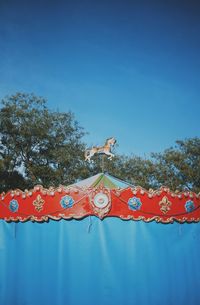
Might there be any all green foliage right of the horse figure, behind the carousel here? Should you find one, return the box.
[86,138,200,192]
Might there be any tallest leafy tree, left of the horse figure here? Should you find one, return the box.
[0,93,86,190]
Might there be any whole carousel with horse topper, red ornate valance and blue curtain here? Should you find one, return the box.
[0,138,200,305]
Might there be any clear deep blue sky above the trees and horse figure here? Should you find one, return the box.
[0,0,200,156]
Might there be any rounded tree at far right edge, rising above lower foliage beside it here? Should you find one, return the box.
[152,137,200,192]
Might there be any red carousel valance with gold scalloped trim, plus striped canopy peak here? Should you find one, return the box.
[0,174,200,223]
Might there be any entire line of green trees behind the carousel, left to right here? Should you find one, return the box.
[0,93,200,192]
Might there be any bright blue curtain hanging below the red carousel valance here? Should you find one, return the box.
[0,217,200,305]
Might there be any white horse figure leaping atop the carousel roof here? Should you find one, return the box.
[85,138,117,162]
